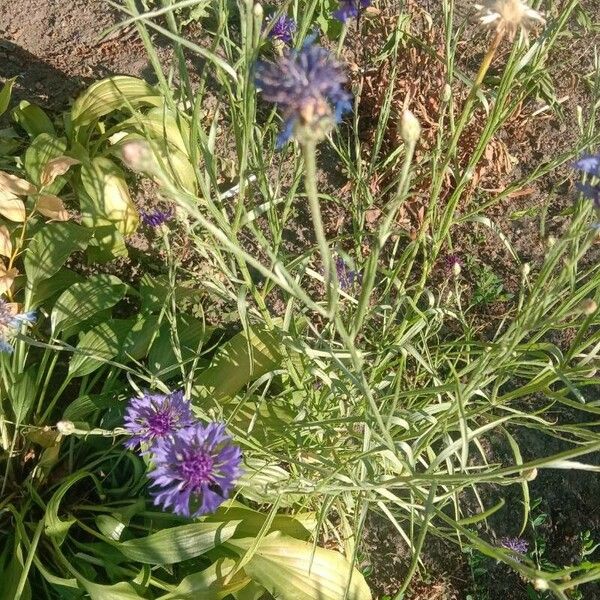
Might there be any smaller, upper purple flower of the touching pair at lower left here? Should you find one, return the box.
[124,391,194,450]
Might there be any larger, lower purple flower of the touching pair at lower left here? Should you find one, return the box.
[148,423,242,517]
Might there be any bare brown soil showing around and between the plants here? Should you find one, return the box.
[0,0,600,600]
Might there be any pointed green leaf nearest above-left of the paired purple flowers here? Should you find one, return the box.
[69,320,131,377]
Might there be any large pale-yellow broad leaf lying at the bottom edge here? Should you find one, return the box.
[226,532,371,600]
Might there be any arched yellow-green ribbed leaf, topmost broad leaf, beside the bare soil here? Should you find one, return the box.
[71,75,163,127]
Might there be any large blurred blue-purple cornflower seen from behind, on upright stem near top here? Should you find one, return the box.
[256,40,352,147]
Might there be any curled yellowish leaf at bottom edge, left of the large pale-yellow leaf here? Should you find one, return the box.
[159,558,251,600]
